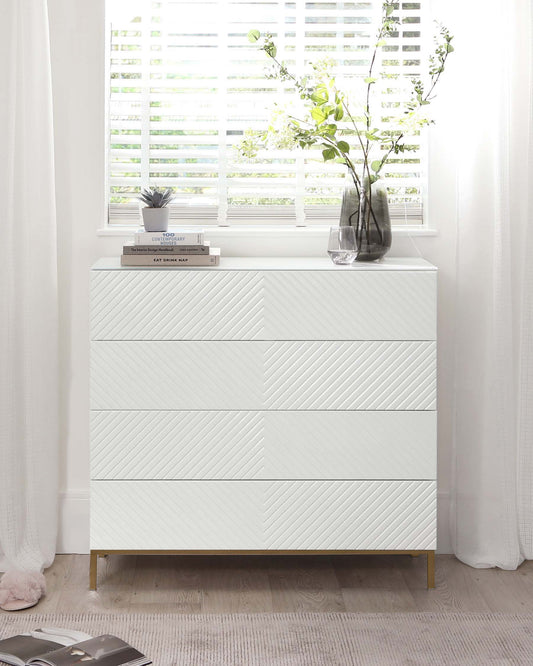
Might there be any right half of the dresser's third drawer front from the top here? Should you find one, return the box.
[263,411,437,479]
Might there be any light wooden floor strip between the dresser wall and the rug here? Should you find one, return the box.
[24,555,533,613]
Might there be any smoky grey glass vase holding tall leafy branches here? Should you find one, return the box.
[339,174,392,261]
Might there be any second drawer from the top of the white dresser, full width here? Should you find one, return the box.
[91,341,436,410]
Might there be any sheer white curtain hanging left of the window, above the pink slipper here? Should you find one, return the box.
[0,0,58,571]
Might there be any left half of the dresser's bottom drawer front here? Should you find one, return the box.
[91,481,263,550]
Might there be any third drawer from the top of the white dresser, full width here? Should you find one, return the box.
[91,411,436,479]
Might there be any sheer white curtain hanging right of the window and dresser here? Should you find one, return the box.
[452,0,533,569]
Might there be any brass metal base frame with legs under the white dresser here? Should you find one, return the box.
[89,550,435,590]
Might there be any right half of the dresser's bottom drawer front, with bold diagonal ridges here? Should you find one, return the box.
[264,481,436,550]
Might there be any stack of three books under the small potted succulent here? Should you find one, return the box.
[121,227,220,266]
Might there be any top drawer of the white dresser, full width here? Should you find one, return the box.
[91,270,437,340]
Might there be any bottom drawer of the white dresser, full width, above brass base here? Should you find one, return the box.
[91,481,436,550]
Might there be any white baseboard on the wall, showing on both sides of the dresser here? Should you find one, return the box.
[57,490,452,554]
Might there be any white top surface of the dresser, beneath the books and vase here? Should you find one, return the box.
[92,257,437,272]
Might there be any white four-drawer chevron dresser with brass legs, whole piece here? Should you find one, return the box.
[90,257,437,589]
